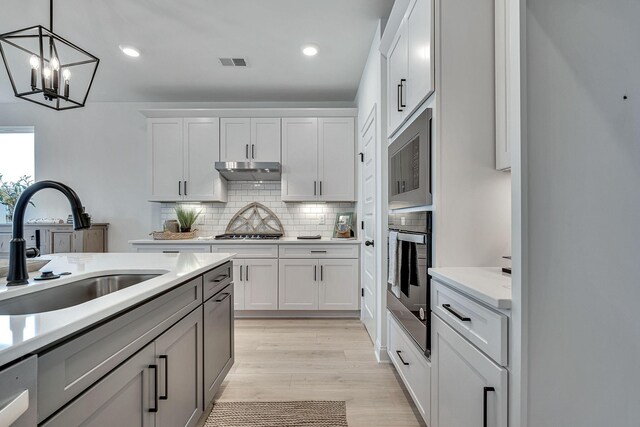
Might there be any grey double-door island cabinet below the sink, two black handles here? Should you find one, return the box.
[44,309,204,427]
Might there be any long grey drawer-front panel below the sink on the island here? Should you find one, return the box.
[38,277,202,422]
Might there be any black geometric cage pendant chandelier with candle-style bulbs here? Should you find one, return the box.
[0,0,100,111]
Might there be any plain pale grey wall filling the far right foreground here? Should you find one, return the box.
[523,0,640,427]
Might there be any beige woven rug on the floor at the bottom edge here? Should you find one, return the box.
[205,401,348,427]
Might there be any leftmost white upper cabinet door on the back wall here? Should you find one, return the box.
[147,119,184,202]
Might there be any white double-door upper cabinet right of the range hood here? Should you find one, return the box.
[282,117,356,202]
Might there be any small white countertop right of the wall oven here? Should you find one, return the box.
[429,267,511,309]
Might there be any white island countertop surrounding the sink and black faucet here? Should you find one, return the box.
[0,253,234,366]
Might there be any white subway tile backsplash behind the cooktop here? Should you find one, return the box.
[160,181,356,237]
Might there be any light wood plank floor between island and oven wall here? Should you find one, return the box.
[216,319,424,427]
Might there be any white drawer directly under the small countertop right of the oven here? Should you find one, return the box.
[431,280,508,366]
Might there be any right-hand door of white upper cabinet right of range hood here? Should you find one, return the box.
[318,117,356,202]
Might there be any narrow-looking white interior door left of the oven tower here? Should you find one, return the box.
[360,107,380,341]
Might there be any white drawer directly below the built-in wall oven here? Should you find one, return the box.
[387,311,431,424]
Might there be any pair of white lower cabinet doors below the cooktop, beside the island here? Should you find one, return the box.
[233,259,278,310]
